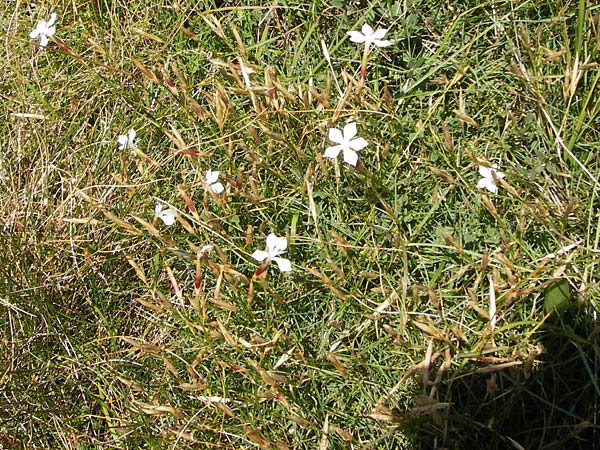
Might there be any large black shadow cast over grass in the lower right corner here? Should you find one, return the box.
[409,312,600,450]
